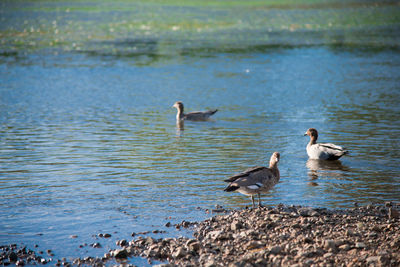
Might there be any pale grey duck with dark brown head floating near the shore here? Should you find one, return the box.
[304,128,349,160]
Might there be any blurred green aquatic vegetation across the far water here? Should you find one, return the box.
[0,0,400,55]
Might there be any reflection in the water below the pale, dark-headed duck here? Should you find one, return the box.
[306,159,349,186]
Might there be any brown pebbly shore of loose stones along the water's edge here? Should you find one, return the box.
[0,203,400,267]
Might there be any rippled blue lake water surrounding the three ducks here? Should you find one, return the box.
[0,0,400,265]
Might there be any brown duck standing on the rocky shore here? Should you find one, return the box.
[224,152,280,209]
